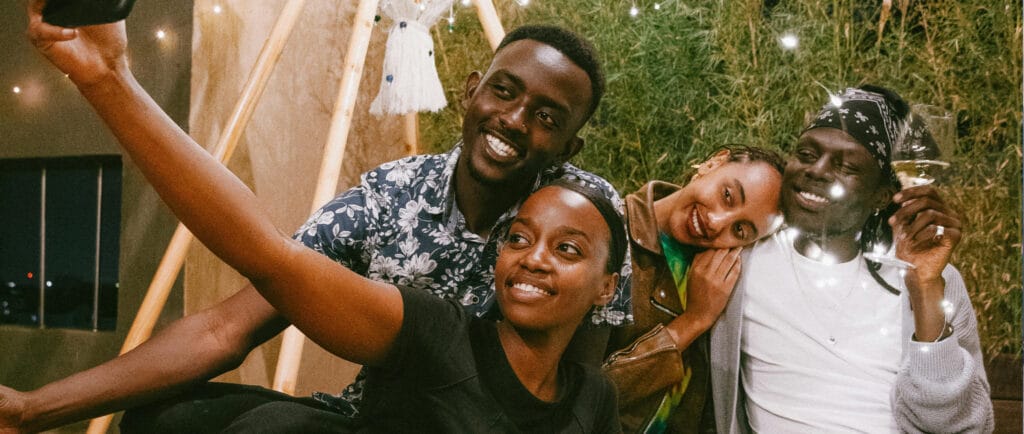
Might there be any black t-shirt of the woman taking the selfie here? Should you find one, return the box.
[352,287,620,433]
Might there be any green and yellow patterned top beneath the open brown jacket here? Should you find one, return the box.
[643,233,697,434]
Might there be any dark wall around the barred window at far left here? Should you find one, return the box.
[0,0,193,431]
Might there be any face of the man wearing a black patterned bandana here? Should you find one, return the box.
[782,128,892,235]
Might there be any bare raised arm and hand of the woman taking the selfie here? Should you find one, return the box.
[29,1,402,364]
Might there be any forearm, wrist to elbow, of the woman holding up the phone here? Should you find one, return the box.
[80,64,287,277]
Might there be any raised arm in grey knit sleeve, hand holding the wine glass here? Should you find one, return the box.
[889,185,993,432]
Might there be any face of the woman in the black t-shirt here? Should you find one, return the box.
[495,186,617,331]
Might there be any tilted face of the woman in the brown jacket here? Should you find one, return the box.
[658,162,782,249]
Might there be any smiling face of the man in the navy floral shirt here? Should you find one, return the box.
[460,39,591,185]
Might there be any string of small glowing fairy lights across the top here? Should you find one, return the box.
[9,0,800,102]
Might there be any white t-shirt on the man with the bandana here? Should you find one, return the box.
[737,232,902,433]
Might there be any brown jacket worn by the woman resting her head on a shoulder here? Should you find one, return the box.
[603,181,715,433]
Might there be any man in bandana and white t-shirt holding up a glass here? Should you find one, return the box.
[711,86,993,433]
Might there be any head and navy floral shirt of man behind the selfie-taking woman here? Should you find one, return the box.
[295,27,632,414]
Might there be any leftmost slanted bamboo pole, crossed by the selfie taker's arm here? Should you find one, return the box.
[86,0,305,434]
